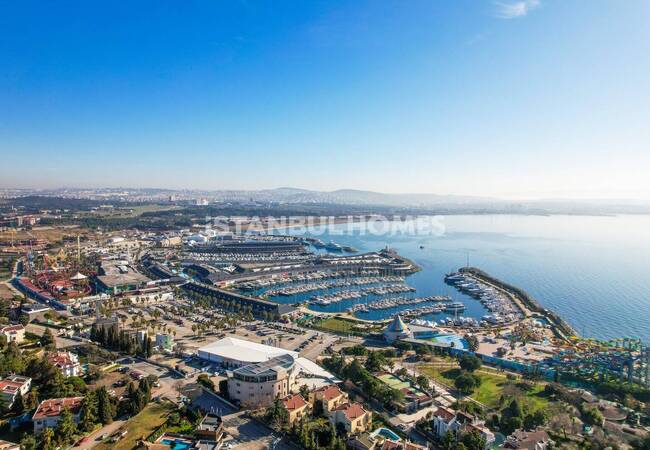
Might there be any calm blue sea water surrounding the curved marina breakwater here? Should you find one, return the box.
[280,215,650,342]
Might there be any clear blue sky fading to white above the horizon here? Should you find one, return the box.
[0,0,650,199]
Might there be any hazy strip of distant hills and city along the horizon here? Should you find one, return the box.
[0,187,650,214]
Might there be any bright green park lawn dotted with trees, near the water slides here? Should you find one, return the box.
[418,366,548,411]
